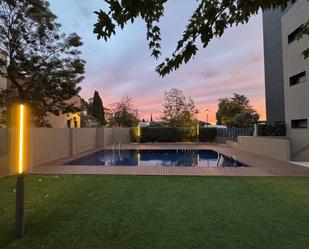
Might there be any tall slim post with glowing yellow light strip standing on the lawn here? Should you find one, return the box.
[15,104,25,239]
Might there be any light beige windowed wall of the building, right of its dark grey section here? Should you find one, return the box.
[281,0,309,161]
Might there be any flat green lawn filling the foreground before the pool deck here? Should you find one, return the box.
[0,176,309,249]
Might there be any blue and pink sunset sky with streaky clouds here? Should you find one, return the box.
[50,0,265,122]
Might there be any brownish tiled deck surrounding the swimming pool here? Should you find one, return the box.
[33,143,309,176]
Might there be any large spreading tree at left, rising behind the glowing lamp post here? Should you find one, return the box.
[0,0,85,126]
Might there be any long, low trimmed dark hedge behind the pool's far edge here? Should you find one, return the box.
[131,127,217,143]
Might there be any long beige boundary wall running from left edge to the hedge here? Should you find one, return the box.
[0,128,130,177]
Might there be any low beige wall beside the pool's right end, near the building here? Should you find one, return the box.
[226,136,291,161]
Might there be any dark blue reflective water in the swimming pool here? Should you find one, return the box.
[66,150,248,167]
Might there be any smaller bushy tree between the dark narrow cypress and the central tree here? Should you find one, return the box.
[109,95,138,127]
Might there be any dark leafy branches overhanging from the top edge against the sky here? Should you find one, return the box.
[94,0,304,76]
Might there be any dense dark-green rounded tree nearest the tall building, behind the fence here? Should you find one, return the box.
[216,93,259,127]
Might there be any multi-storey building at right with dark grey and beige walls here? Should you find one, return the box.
[264,0,309,161]
